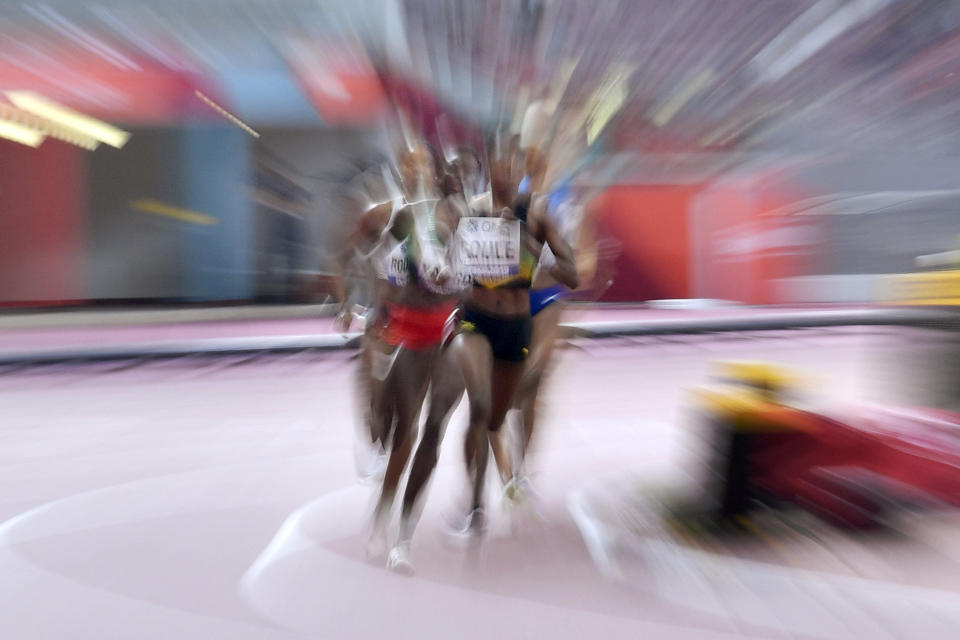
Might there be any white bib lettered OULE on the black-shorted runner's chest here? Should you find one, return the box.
[457,218,520,277]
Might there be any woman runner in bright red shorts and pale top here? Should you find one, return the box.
[368,140,459,556]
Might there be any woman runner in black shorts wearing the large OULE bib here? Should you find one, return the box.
[452,132,579,535]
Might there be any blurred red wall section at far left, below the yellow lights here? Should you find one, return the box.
[0,139,87,305]
